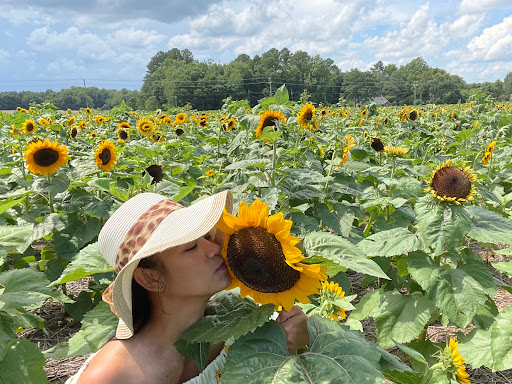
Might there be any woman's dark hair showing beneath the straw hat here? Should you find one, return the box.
[132,255,161,334]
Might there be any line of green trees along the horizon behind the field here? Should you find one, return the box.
[0,48,512,110]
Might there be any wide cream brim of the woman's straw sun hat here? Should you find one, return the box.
[112,191,233,339]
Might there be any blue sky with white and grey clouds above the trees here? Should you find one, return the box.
[0,0,512,92]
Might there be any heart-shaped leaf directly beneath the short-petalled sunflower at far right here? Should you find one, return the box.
[414,196,471,256]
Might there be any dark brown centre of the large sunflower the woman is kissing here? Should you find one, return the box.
[227,227,300,293]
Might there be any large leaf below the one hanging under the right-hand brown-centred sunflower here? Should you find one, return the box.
[407,251,488,328]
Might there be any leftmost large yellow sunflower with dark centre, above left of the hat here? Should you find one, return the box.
[23,140,69,176]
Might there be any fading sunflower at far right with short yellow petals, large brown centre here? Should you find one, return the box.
[427,159,476,204]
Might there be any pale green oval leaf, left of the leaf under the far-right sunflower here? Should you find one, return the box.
[357,228,421,256]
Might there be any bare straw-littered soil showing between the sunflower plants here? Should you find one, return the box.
[20,246,512,384]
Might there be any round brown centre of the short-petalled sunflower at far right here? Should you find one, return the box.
[432,167,471,199]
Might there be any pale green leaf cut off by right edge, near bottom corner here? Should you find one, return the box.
[458,306,512,371]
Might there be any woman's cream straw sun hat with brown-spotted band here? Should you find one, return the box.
[98,191,233,339]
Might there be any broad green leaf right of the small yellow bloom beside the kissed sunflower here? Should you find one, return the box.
[374,291,435,348]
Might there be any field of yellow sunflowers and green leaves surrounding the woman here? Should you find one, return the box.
[0,85,512,384]
